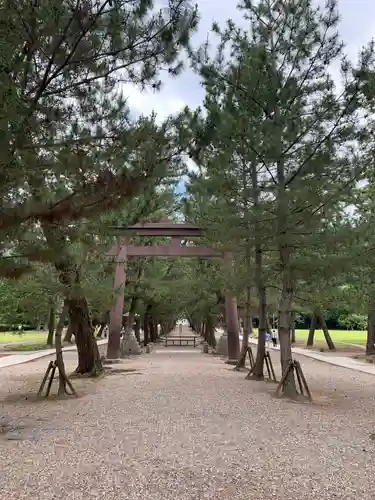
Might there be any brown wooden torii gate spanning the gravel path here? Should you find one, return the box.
[107,222,240,363]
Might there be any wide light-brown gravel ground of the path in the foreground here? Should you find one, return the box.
[0,344,375,500]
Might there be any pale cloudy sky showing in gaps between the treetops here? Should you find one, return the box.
[124,0,375,191]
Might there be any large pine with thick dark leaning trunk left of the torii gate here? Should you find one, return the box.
[0,0,197,373]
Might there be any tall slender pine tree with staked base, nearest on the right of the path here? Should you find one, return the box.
[189,0,372,396]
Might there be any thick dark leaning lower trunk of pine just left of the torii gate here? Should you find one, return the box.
[67,297,102,376]
